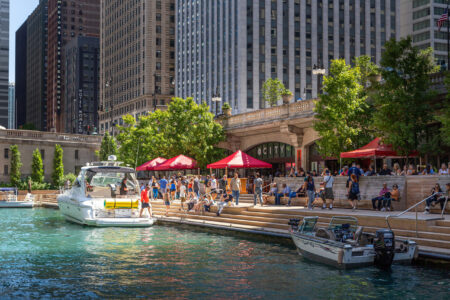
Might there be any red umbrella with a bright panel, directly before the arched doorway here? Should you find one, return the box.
[207,150,272,169]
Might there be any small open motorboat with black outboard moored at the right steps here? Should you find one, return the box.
[289,216,418,269]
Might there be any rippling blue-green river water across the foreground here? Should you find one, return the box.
[0,209,450,299]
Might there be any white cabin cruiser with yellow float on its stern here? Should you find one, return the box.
[58,156,155,227]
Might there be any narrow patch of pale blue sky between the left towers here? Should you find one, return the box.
[9,0,39,82]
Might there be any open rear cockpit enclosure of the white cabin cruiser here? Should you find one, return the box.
[84,170,139,198]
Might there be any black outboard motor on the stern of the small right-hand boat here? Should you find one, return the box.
[373,229,395,269]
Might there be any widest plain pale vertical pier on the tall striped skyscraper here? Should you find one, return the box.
[235,1,247,112]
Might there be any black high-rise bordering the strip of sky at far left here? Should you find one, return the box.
[25,0,48,131]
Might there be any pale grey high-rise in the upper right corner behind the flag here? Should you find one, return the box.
[400,0,450,66]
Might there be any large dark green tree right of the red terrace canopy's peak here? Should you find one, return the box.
[373,37,436,156]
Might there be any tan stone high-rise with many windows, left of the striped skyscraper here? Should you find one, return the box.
[99,0,175,133]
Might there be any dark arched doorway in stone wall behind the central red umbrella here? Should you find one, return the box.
[245,142,295,175]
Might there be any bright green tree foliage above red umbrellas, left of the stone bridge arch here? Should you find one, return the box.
[117,98,225,167]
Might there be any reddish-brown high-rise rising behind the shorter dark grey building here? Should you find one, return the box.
[47,0,99,132]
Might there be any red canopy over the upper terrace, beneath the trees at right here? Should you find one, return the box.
[341,138,418,158]
